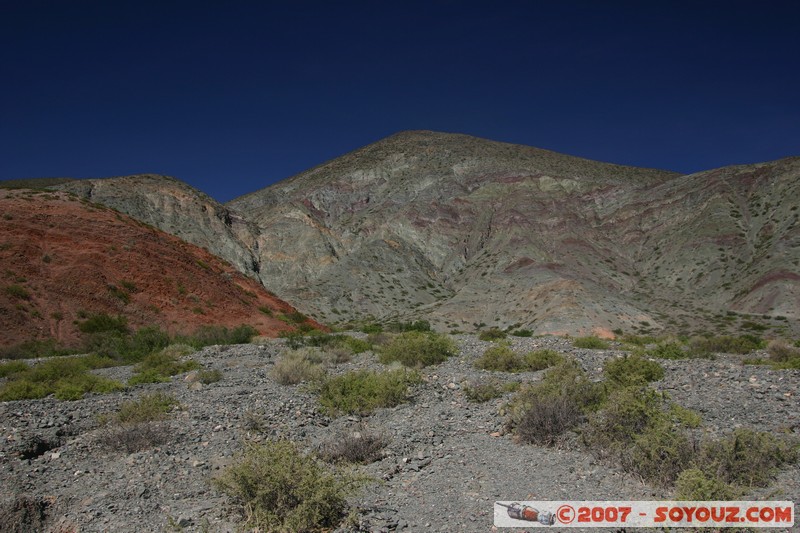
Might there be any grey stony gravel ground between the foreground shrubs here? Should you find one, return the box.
[0,335,800,532]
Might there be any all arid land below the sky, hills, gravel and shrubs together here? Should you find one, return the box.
[0,131,800,533]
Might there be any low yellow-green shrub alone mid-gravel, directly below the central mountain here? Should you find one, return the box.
[319,369,421,415]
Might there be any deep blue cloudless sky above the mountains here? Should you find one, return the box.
[0,0,800,201]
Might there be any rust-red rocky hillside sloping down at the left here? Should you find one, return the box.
[0,190,319,347]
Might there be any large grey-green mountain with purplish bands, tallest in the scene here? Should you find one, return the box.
[228,132,800,333]
